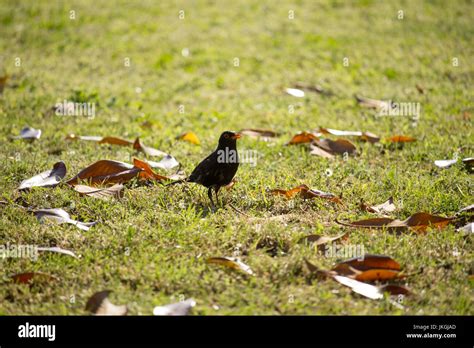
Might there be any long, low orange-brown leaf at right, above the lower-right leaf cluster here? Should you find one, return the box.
[336,213,454,232]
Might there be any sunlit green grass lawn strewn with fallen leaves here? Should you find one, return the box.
[0,0,474,315]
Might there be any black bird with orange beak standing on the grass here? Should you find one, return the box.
[171,131,241,205]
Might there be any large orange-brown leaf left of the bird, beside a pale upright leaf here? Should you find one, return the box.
[66,160,143,186]
